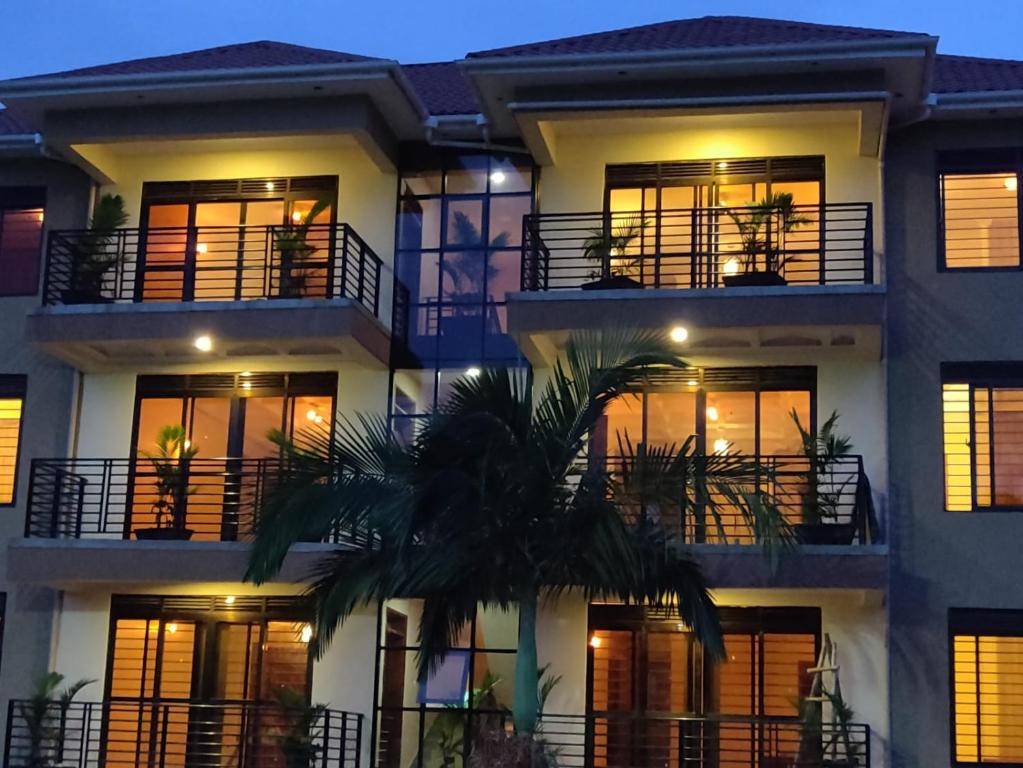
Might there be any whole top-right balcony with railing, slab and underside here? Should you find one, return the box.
[508,202,883,364]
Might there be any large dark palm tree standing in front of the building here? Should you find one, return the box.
[247,330,769,752]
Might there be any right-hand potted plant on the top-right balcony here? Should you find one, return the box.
[721,192,810,287]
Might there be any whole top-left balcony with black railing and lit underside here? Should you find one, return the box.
[28,224,390,371]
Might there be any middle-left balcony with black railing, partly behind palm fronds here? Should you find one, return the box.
[10,457,365,583]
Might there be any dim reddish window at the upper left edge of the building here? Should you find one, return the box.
[0,187,46,296]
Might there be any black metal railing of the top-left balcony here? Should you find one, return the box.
[43,224,383,315]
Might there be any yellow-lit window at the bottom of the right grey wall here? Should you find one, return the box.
[948,609,1023,765]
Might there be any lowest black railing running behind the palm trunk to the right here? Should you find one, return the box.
[376,707,871,768]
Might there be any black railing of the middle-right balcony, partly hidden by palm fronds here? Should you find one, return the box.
[594,454,878,545]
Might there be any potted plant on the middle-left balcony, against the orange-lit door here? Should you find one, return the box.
[135,424,198,540]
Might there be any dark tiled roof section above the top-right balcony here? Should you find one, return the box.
[469,16,928,58]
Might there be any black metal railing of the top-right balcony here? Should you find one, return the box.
[522,202,875,290]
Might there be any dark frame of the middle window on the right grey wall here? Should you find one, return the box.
[939,362,1023,514]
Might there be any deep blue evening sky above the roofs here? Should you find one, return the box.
[0,0,1023,79]
